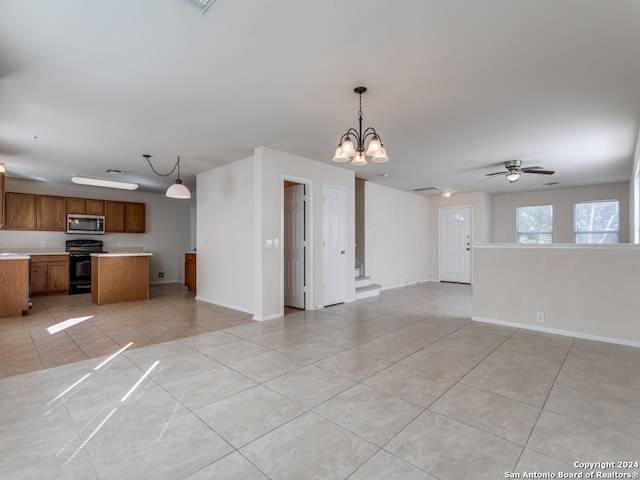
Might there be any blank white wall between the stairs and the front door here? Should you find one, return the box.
[363,182,430,289]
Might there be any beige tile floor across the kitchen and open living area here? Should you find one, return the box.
[0,283,640,480]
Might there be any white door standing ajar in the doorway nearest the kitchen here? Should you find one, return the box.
[284,185,305,308]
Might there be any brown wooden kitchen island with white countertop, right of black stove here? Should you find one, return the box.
[91,252,153,305]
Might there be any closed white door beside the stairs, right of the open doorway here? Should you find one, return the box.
[322,186,347,306]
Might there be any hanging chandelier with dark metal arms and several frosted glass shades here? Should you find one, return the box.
[333,87,389,165]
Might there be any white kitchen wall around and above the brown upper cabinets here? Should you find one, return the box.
[0,177,191,283]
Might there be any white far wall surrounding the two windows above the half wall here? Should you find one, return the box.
[493,182,630,243]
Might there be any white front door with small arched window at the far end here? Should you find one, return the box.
[438,207,471,283]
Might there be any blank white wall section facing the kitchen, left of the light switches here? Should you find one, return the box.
[196,157,257,313]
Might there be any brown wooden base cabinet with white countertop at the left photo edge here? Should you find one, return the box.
[0,253,29,318]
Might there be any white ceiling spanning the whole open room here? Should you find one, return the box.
[0,0,640,193]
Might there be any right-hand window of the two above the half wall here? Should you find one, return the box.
[573,200,620,243]
